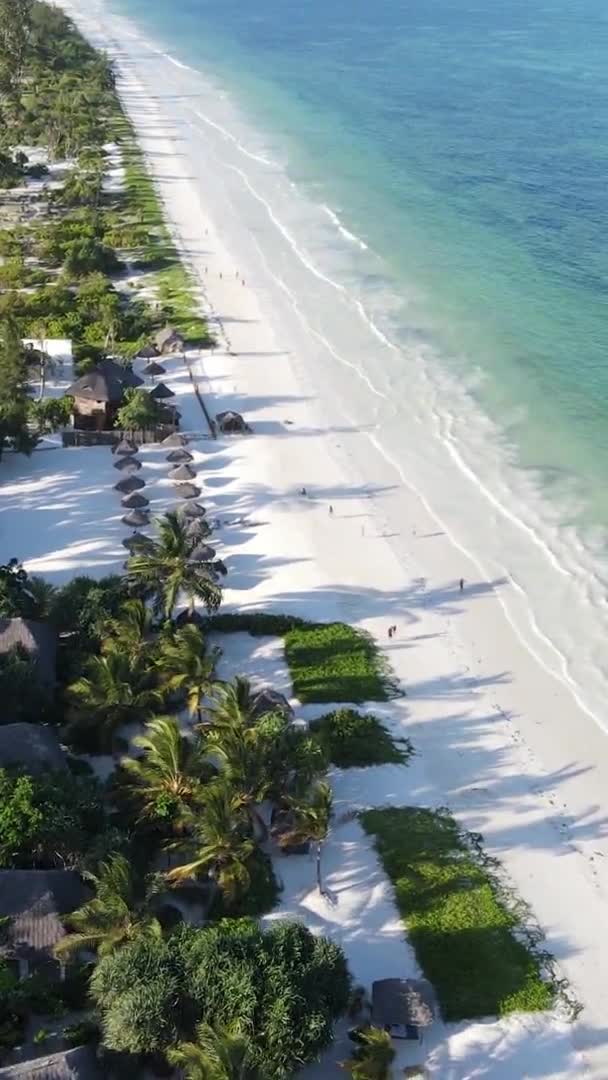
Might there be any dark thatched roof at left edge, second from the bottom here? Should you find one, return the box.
[0,870,87,956]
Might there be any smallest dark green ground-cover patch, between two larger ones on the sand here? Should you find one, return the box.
[310,708,413,769]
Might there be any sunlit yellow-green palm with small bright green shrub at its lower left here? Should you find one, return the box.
[122,716,204,835]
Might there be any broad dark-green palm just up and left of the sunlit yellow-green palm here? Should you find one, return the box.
[67,647,163,750]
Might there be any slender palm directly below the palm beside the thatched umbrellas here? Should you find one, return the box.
[158,623,220,723]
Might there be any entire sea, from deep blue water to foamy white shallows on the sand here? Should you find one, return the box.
[112,0,608,723]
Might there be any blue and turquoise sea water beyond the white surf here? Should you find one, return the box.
[111,0,608,525]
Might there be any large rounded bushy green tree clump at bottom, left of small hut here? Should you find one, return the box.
[92,919,350,1080]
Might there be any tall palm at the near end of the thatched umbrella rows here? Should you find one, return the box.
[127,513,221,619]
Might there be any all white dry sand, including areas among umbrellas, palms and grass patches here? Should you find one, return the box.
[0,0,608,1080]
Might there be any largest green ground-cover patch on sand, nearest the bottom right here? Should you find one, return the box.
[361,808,556,1021]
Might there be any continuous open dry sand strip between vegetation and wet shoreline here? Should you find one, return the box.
[29,0,608,1080]
